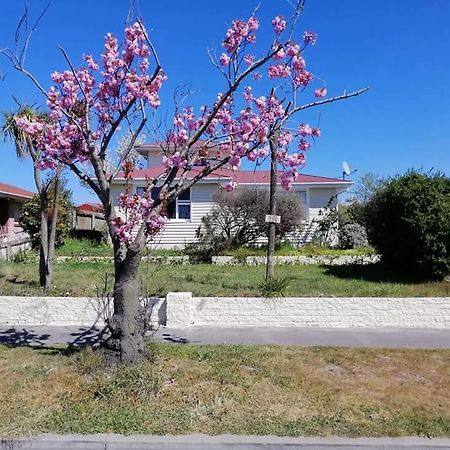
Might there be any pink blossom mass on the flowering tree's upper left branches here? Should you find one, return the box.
[18,23,166,174]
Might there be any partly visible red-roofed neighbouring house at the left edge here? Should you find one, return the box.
[0,183,34,259]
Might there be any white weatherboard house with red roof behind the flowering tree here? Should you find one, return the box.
[112,144,352,248]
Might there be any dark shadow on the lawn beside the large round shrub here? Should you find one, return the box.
[324,263,433,284]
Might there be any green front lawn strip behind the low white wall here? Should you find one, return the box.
[0,260,450,297]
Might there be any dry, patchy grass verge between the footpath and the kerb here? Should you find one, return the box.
[0,344,450,436]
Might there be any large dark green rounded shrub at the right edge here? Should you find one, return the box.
[367,171,450,278]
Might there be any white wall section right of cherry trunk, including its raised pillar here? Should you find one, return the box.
[167,293,450,328]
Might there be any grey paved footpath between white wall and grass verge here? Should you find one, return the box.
[0,325,450,348]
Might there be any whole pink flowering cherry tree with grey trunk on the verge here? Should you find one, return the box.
[6,0,365,362]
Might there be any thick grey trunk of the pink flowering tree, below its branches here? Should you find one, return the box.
[105,244,146,363]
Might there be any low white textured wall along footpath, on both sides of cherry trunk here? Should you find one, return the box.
[0,292,450,329]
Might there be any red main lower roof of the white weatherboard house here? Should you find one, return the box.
[116,166,351,184]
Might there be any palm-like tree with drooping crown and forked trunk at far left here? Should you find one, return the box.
[1,105,62,288]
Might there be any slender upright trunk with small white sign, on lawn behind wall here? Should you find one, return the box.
[266,134,278,280]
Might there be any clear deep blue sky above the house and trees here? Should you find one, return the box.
[0,0,450,202]
